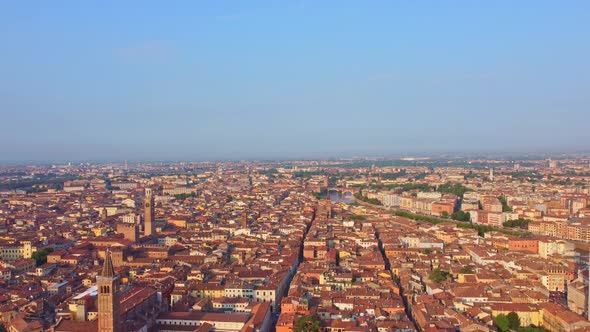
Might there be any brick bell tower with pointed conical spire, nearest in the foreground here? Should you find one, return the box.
[96,249,121,332]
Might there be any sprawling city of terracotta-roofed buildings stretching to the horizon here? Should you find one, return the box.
[0,156,590,332]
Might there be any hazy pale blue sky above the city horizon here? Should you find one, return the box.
[0,0,590,162]
